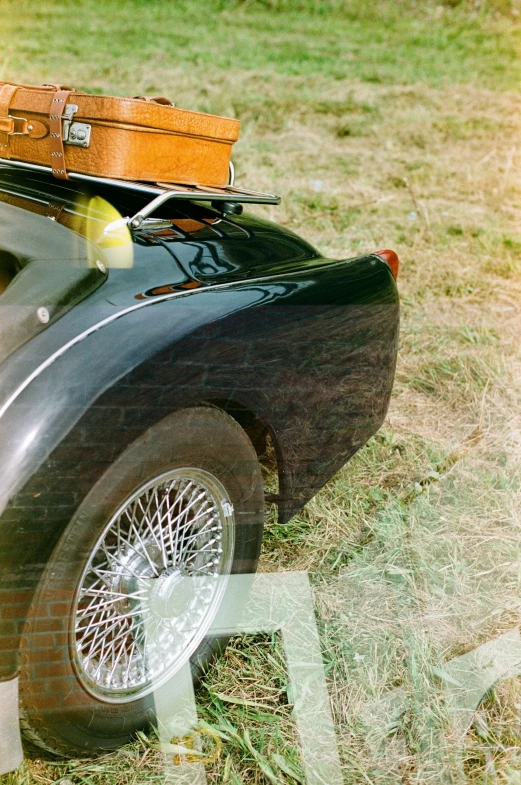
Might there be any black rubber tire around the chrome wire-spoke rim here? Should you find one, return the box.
[20,407,264,757]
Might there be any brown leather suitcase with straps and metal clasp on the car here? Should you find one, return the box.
[0,82,240,186]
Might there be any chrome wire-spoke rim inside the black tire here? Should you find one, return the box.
[73,468,234,703]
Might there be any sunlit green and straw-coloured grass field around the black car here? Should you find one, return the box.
[0,0,521,785]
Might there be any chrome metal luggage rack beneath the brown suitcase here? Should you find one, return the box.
[0,158,280,229]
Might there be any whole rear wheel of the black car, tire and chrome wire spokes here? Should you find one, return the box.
[20,407,263,755]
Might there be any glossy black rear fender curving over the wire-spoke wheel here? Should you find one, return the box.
[0,257,398,676]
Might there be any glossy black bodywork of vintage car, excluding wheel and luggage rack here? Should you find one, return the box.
[0,165,399,751]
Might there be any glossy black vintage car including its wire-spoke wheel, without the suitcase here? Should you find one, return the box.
[0,163,399,756]
